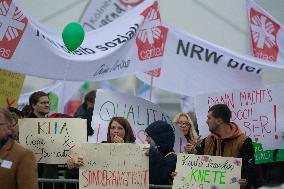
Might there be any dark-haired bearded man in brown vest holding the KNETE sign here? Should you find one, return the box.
[191,104,254,189]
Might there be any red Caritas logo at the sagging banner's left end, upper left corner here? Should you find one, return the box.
[0,0,28,59]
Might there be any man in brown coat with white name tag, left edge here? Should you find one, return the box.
[0,108,38,189]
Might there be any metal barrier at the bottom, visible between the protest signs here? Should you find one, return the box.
[38,178,172,189]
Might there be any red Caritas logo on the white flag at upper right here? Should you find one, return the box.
[250,8,280,61]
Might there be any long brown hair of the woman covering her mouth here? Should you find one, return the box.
[107,117,136,143]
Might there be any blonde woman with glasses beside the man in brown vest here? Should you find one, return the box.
[173,112,201,153]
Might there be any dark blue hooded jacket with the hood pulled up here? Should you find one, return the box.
[145,121,177,185]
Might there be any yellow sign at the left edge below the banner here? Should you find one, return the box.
[0,69,25,108]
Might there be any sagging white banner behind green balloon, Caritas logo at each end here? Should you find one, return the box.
[0,0,164,81]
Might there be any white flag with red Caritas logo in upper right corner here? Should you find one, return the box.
[246,0,284,64]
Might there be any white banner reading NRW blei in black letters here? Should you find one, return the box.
[137,23,284,96]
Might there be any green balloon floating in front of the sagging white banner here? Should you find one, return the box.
[62,22,85,52]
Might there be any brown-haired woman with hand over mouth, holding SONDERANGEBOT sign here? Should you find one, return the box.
[67,117,135,169]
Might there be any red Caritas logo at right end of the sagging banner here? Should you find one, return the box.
[136,2,168,61]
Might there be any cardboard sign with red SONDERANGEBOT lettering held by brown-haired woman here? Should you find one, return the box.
[79,143,149,189]
